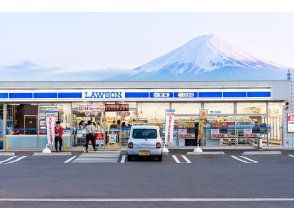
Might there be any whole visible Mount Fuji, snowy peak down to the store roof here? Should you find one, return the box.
[115,35,288,81]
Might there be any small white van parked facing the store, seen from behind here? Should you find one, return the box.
[128,125,162,161]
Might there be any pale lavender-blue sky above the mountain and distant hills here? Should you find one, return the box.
[0,12,294,70]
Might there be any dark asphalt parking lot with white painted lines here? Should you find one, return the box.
[0,152,294,207]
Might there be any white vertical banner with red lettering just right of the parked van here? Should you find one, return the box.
[164,109,176,146]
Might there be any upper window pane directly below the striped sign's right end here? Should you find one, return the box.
[237,102,266,115]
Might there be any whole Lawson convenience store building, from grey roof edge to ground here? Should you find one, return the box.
[0,80,294,149]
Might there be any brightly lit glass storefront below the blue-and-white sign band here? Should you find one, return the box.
[0,101,283,148]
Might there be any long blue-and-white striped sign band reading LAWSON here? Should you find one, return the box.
[0,89,272,102]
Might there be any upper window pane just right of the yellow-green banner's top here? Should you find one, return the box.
[204,102,234,115]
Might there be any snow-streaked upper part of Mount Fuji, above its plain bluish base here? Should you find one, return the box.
[136,34,283,74]
